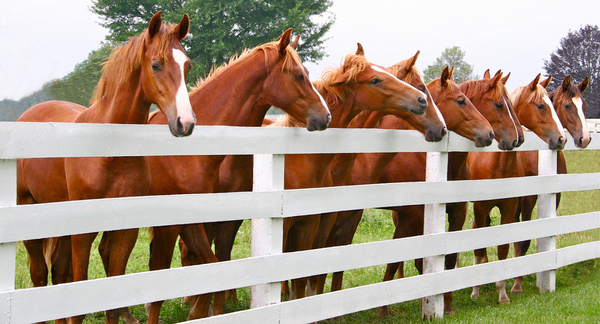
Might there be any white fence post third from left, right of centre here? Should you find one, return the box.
[421,152,448,320]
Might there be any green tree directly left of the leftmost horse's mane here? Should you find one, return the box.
[43,42,115,107]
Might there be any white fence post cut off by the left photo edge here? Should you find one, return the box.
[0,160,17,323]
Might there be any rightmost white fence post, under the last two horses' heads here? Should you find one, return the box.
[537,150,558,292]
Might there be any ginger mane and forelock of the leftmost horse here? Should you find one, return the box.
[90,23,177,104]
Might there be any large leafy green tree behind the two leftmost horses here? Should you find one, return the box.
[90,0,335,82]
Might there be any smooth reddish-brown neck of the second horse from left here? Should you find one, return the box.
[190,51,271,126]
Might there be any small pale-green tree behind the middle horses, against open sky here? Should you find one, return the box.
[423,46,479,83]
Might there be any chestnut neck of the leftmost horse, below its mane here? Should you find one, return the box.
[77,70,151,124]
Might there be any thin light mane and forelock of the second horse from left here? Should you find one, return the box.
[190,41,302,95]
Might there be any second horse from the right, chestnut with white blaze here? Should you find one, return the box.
[467,74,566,304]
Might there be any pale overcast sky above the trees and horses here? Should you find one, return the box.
[0,0,600,100]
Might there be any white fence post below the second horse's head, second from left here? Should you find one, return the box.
[250,154,285,308]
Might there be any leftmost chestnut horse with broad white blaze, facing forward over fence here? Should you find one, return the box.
[17,12,196,323]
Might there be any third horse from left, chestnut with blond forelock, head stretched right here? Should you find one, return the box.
[271,45,427,299]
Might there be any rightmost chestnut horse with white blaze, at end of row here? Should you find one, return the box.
[510,75,590,293]
